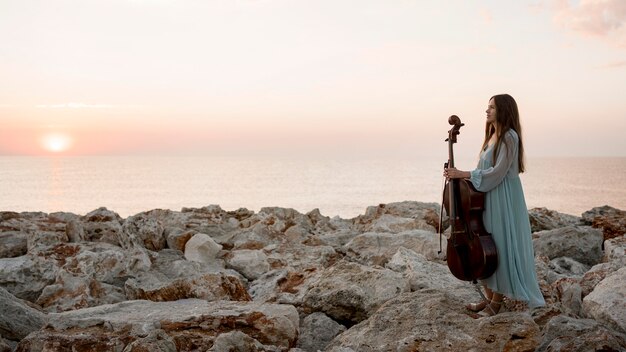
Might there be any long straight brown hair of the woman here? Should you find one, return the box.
[483,94,525,173]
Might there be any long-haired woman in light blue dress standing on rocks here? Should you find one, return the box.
[444,94,545,315]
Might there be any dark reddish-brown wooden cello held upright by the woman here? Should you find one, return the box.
[439,115,498,283]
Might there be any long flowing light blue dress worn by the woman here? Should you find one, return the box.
[470,130,545,309]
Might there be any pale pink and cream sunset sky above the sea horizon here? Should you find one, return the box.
[0,0,626,157]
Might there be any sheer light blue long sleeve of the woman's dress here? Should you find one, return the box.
[470,130,519,192]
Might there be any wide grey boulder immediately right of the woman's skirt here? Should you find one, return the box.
[533,226,603,265]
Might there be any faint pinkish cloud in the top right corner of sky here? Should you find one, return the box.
[553,0,626,49]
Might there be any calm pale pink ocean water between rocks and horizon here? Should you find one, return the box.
[0,157,626,218]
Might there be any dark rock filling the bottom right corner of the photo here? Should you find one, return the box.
[536,315,626,352]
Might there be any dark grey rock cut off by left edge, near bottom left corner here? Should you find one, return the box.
[0,287,46,340]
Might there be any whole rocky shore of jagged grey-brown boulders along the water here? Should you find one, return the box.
[0,201,626,352]
